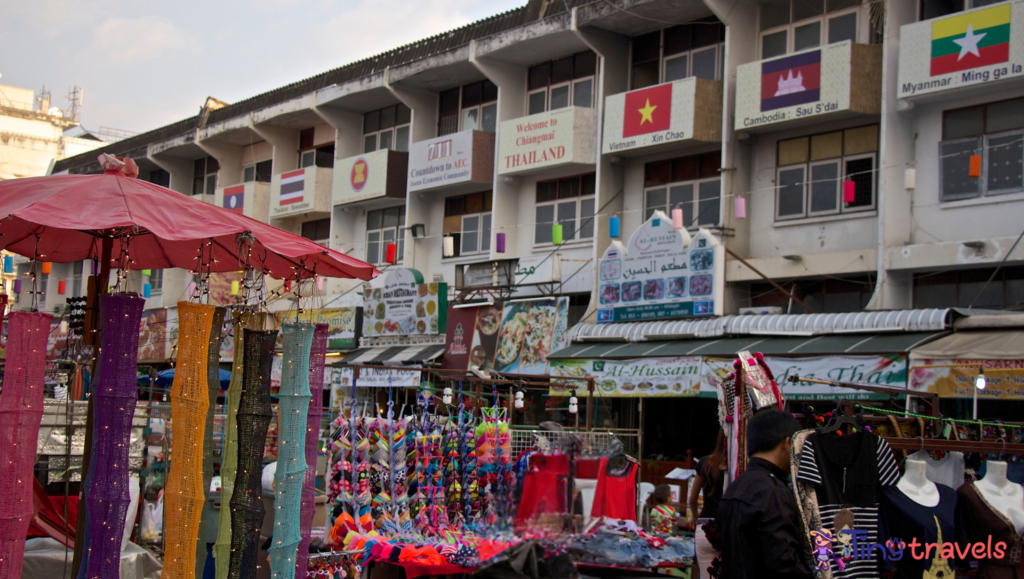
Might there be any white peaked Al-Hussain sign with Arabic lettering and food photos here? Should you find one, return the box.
[597,211,725,322]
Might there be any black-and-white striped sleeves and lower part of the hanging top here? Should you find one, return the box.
[797,439,899,579]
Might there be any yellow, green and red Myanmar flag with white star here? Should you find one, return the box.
[932,4,1010,77]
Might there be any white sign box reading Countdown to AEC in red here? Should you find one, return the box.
[409,130,495,192]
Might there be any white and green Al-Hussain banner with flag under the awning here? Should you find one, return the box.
[550,356,701,398]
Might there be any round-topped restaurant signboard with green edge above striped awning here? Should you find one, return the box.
[362,268,447,336]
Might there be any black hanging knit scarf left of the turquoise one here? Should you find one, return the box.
[230,330,278,579]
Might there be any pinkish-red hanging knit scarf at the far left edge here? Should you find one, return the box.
[0,312,53,579]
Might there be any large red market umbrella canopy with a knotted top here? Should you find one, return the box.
[0,155,380,280]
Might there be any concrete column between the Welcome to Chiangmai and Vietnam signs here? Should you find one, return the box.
[572,8,630,323]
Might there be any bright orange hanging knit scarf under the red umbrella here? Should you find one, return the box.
[161,301,216,579]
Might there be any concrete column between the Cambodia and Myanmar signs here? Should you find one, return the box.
[867,2,916,309]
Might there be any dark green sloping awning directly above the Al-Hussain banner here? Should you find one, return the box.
[548,331,946,360]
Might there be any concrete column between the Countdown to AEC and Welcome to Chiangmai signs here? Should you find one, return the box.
[469,41,526,259]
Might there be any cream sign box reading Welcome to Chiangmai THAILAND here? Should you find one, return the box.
[498,107,597,175]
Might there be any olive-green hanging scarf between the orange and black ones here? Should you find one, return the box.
[213,313,266,579]
